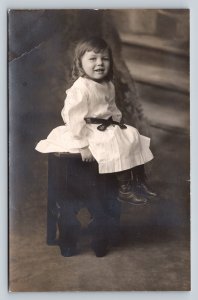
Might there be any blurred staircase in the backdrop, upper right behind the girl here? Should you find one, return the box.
[112,9,189,133]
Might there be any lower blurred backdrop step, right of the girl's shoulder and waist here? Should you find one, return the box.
[136,83,190,134]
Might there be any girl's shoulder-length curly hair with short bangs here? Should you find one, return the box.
[72,37,113,82]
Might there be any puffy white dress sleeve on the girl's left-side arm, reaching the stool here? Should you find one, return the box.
[61,86,88,148]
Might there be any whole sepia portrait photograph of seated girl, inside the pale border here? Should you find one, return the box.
[7,9,191,292]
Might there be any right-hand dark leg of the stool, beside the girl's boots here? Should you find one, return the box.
[86,170,121,257]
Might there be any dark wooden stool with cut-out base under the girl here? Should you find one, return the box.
[47,153,121,255]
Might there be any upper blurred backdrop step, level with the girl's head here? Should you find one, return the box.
[120,33,189,93]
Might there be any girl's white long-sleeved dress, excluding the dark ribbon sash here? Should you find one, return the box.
[36,77,153,173]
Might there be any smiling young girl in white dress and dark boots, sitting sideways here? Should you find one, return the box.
[36,37,155,205]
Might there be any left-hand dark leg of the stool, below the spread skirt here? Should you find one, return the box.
[47,154,80,256]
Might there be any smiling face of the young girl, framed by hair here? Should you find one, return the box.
[81,50,110,80]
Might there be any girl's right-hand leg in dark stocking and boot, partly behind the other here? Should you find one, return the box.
[132,165,157,197]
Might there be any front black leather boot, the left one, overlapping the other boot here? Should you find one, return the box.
[118,181,147,205]
